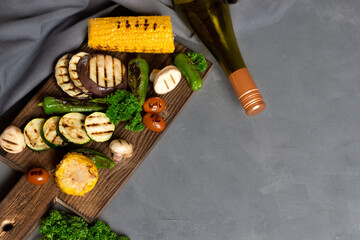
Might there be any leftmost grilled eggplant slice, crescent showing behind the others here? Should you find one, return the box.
[55,54,88,98]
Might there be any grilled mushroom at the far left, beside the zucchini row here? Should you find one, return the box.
[0,125,26,153]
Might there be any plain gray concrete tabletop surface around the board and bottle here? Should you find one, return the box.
[0,0,360,240]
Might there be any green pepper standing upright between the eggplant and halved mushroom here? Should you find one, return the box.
[127,57,149,106]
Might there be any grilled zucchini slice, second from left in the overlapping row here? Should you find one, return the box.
[41,116,67,148]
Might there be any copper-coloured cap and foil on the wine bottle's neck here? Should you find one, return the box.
[229,68,266,116]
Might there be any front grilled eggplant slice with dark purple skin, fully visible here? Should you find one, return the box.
[77,54,127,97]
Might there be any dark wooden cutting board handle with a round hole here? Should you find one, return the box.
[0,175,57,240]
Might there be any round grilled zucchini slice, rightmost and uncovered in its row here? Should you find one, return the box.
[85,112,115,142]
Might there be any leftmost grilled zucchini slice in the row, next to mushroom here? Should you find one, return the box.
[24,118,50,152]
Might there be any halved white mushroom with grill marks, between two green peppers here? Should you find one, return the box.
[150,65,181,94]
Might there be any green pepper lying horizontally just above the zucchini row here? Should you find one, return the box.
[38,96,105,114]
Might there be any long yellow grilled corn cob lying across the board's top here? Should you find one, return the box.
[88,16,175,53]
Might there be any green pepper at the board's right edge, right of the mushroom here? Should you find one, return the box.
[174,53,202,91]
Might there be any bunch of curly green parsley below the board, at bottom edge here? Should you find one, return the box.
[40,210,130,240]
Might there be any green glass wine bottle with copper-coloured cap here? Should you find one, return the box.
[173,0,266,116]
